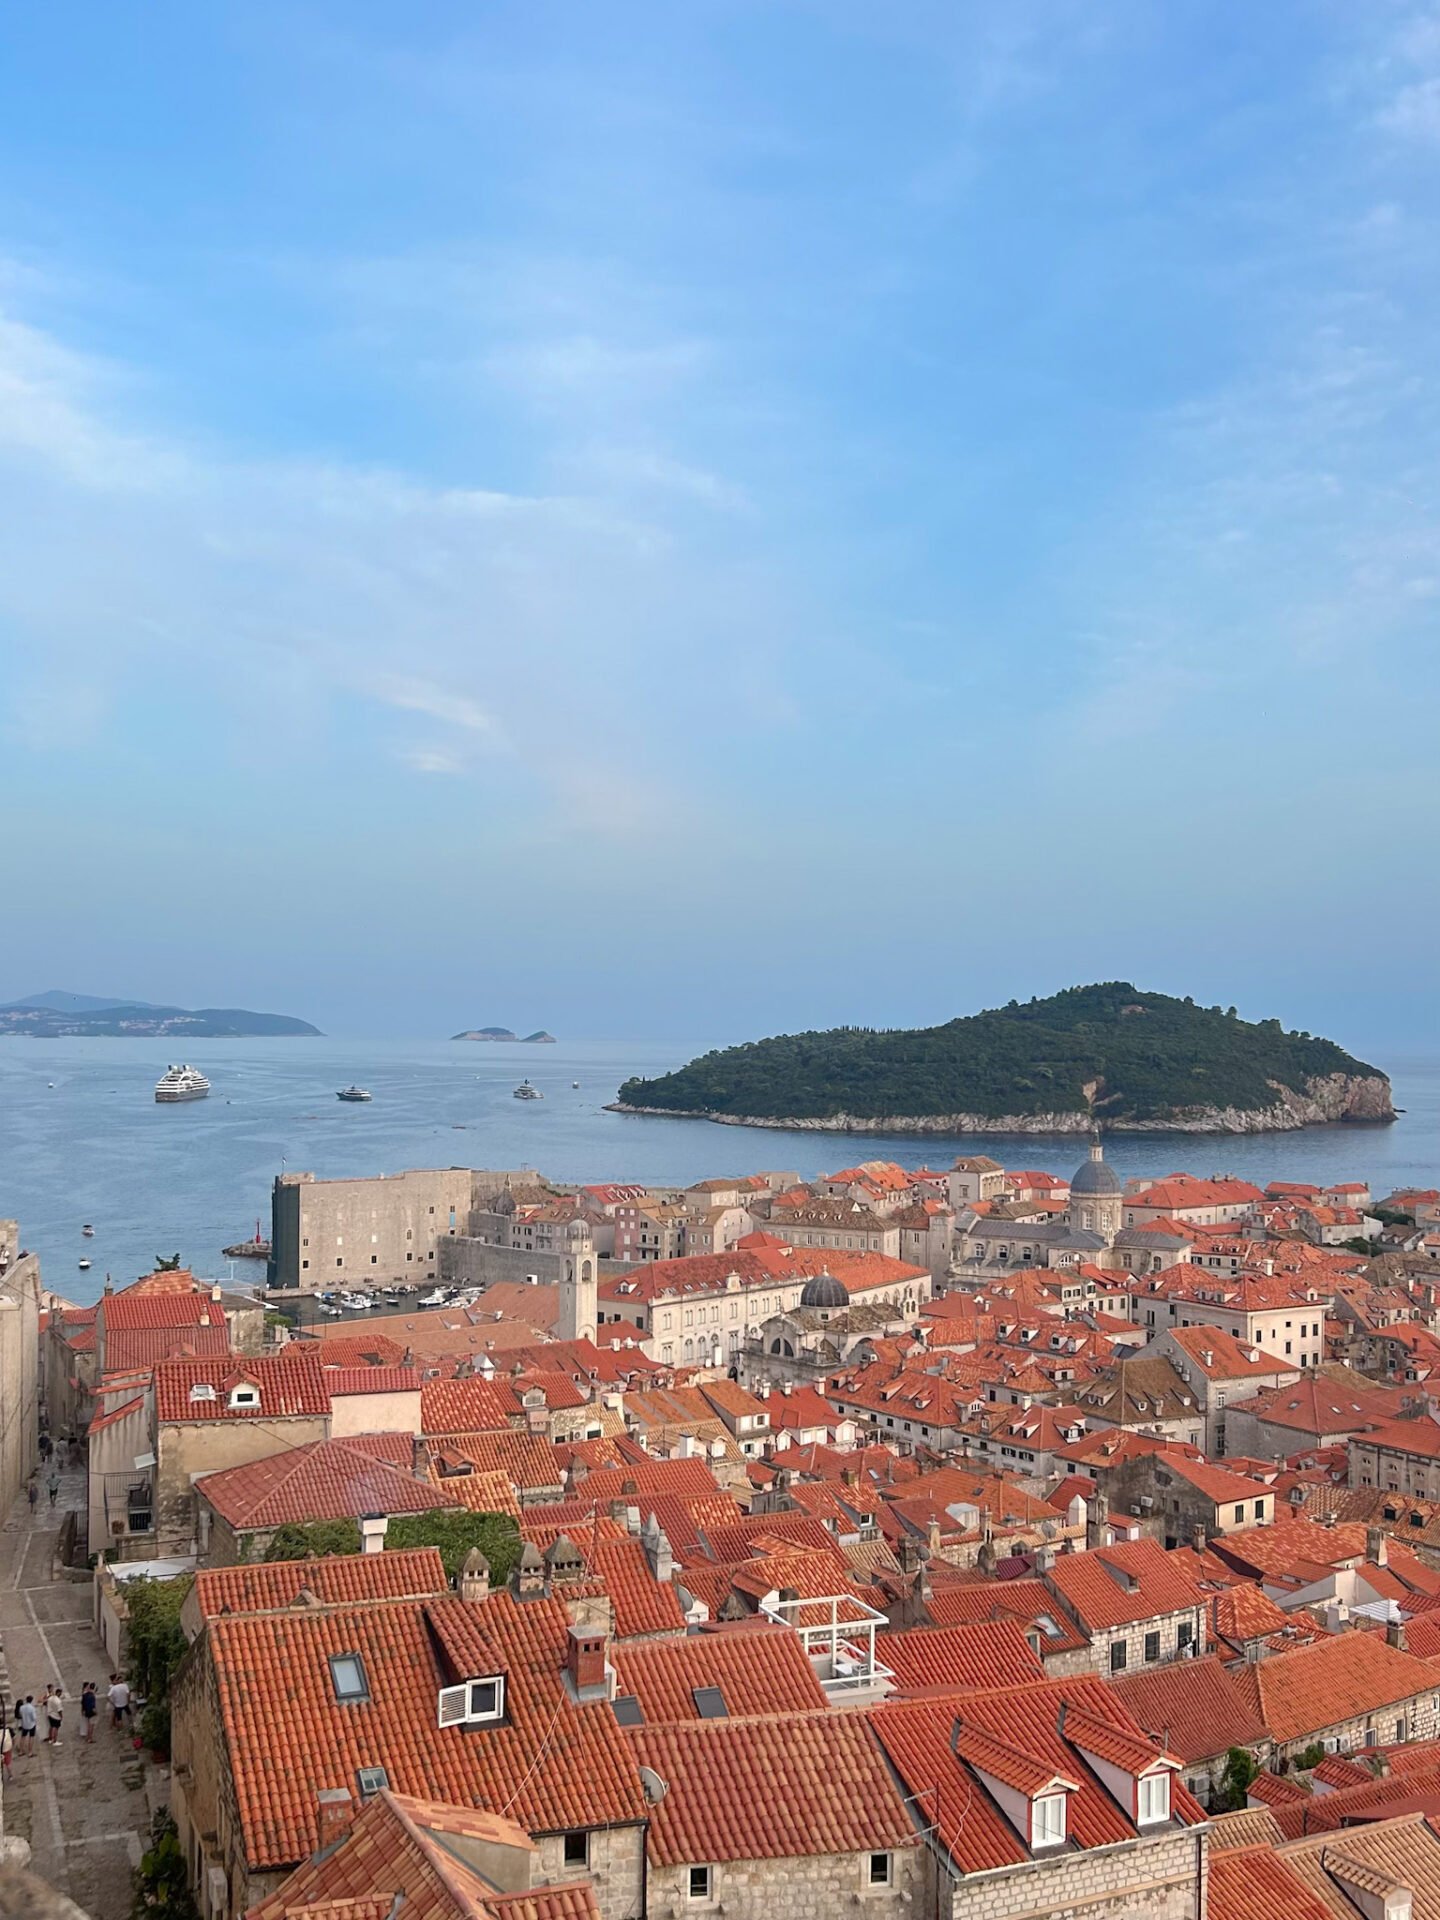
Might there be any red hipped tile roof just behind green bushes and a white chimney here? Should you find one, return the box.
[196,1434,457,1530]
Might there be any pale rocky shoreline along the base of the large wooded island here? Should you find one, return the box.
[605,1073,1396,1135]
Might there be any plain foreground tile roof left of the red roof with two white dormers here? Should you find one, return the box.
[630,1713,920,1866]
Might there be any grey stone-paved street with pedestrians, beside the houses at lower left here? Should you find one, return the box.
[0,1467,163,1920]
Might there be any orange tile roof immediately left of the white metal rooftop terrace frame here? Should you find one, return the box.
[611,1624,828,1726]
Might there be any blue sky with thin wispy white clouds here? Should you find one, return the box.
[0,0,1440,1046]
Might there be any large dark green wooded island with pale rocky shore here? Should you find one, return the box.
[616,981,1394,1133]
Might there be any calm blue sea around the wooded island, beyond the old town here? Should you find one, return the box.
[0,1039,1440,1302]
